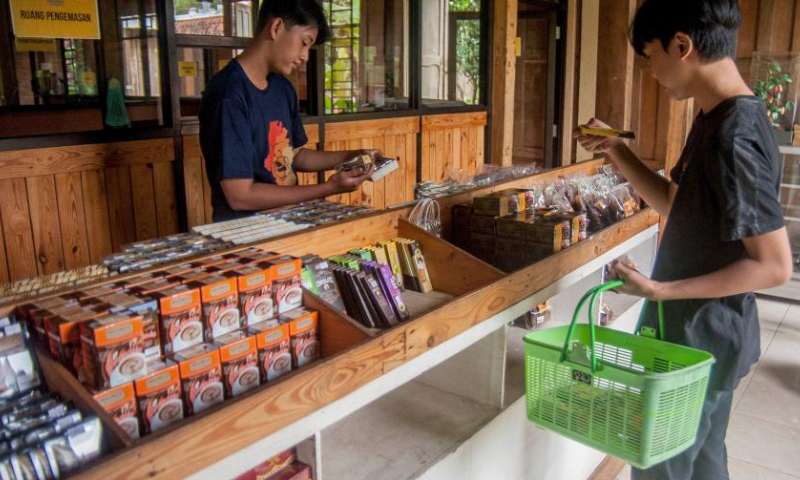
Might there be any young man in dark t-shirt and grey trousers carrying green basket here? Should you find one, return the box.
[575,0,792,480]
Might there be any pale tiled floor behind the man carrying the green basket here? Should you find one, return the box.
[617,298,800,480]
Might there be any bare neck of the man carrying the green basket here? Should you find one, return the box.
[691,58,753,113]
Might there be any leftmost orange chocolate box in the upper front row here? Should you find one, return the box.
[80,312,145,390]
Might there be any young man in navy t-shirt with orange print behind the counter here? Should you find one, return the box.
[199,0,381,222]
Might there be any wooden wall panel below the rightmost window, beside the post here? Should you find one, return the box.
[422,112,486,182]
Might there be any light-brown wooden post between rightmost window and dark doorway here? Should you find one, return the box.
[490,0,518,165]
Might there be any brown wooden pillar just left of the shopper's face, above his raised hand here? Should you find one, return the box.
[596,0,636,129]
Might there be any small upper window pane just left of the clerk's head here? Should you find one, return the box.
[173,0,255,37]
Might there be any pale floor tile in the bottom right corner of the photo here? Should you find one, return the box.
[726,413,800,475]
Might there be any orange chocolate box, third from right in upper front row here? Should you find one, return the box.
[189,275,242,342]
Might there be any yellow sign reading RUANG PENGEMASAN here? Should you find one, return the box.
[10,0,100,39]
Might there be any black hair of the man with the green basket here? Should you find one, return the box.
[630,0,742,61]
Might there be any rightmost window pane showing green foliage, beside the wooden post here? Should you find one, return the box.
[422,0,483,106]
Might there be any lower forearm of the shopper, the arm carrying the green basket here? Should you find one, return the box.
[652,258,783,300]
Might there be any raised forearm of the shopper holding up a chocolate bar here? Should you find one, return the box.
[608,144,672,217]
